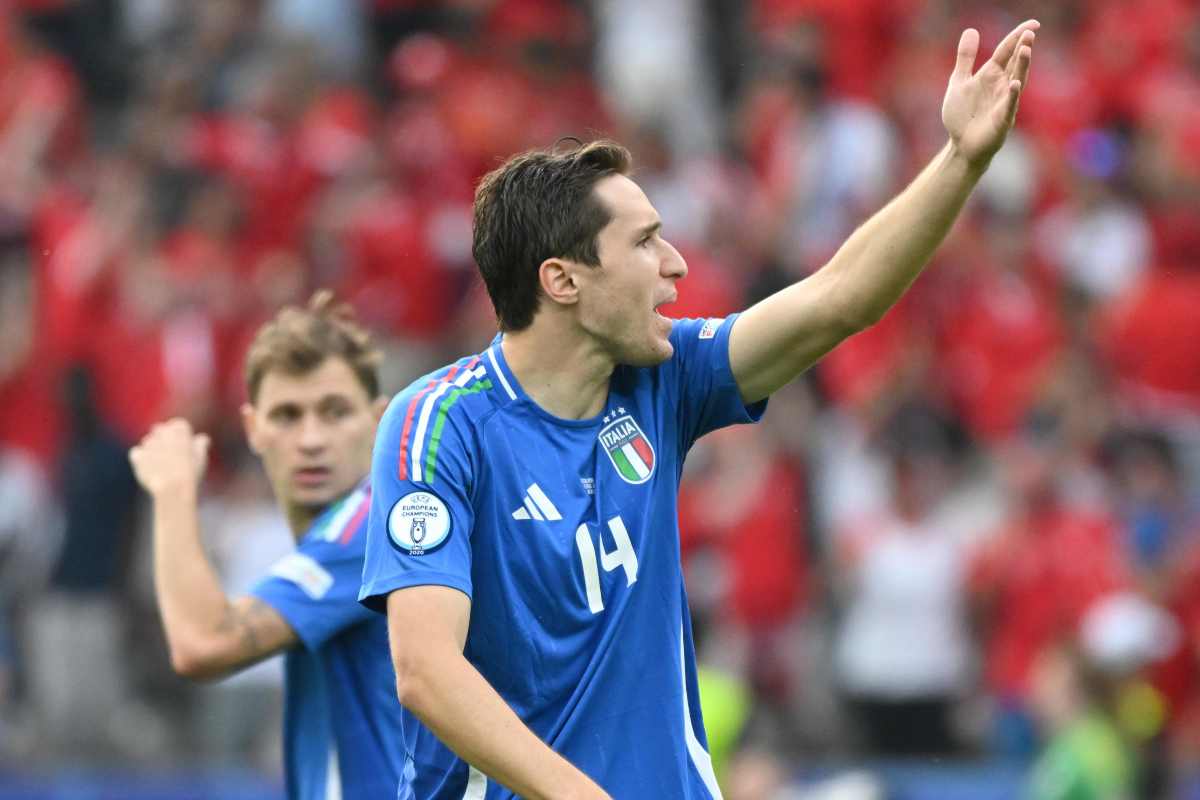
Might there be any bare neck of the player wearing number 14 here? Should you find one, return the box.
[500,323,613,420]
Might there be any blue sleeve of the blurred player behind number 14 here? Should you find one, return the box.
[251,498,371,650]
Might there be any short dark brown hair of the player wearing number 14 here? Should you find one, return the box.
[472,139,632,331]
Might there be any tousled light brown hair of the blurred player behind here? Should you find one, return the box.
[246,289,383,404]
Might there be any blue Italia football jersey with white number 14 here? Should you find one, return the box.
[360,317,764,800]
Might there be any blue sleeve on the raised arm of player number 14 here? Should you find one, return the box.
[671,314,767,447]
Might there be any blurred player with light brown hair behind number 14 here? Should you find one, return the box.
[130,291,403,800]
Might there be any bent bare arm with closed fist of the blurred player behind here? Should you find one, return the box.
[130,420,299,680]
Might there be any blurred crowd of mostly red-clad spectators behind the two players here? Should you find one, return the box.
[0,0,1200,800]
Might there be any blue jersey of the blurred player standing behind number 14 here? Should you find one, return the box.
[252,487,403,800]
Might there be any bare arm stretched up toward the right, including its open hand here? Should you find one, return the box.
[730,20,1039,402]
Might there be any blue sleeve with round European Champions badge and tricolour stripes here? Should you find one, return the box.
[359,390,474,612]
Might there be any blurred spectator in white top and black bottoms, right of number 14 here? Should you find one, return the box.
[835,408,974,757]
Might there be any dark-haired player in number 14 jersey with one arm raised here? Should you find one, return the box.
[361,20,1038,800]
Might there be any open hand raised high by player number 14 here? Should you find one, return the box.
[942,19,1042,167]
